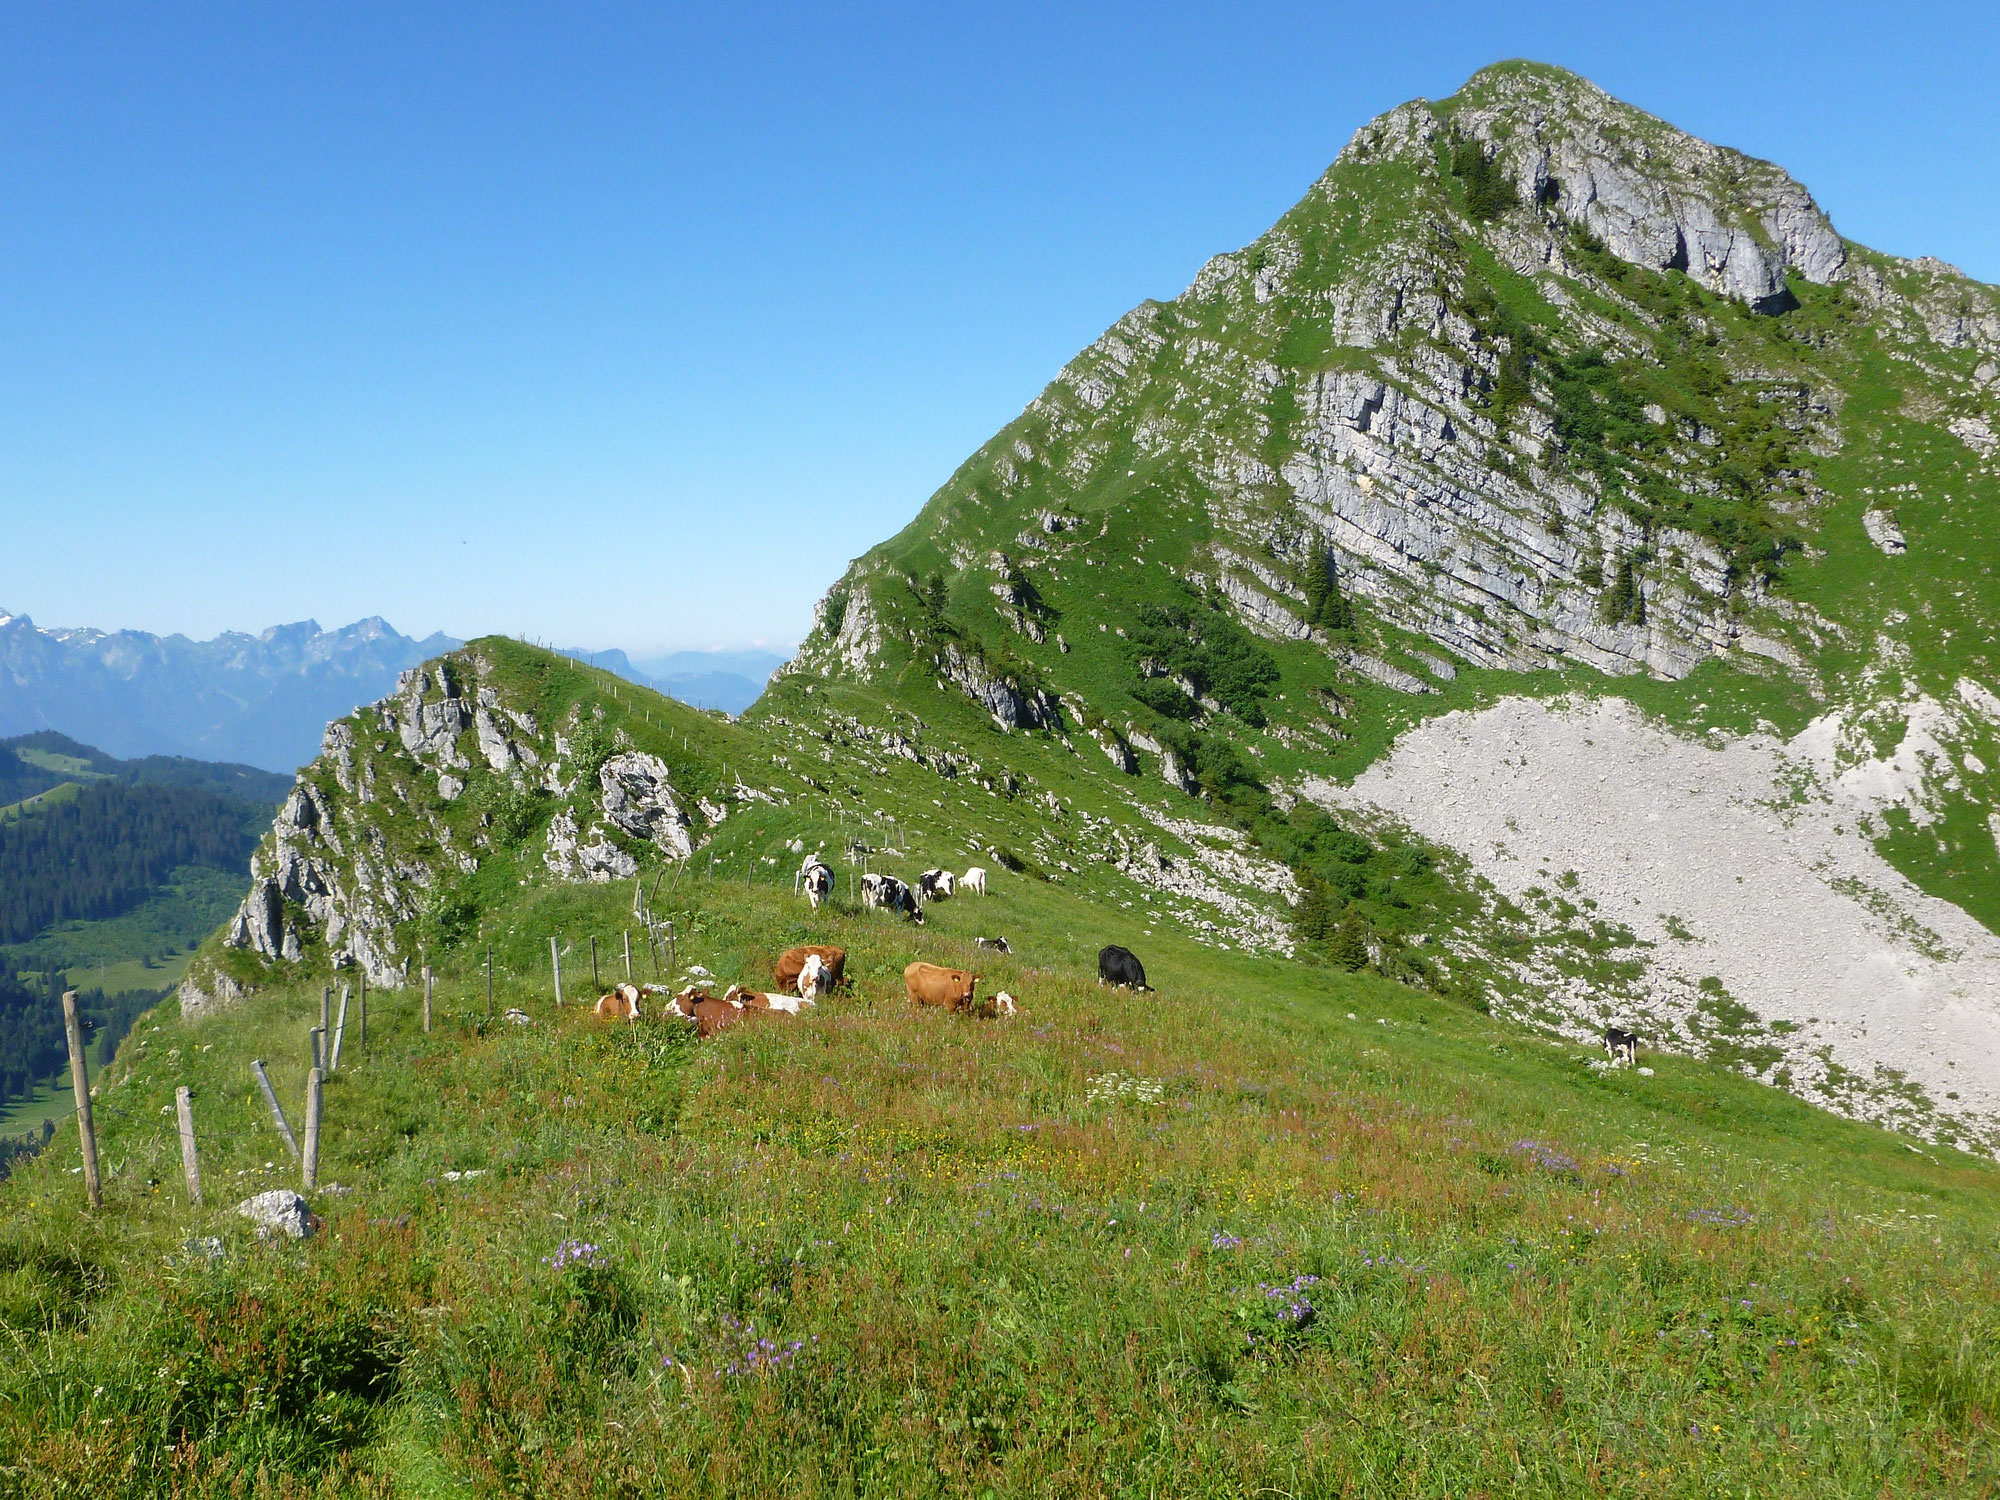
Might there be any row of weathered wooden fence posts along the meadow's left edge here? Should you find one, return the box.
[62,872,696,1208]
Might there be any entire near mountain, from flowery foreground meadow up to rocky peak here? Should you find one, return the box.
[0,62,2000,1496]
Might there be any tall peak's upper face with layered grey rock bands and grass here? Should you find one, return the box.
[804,64,2000,696]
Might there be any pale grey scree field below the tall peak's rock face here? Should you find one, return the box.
[1302,698,2000,1150]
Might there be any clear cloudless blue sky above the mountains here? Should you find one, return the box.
[0,0,2000,652]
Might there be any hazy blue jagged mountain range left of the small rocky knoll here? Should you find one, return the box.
[0,610,458,772]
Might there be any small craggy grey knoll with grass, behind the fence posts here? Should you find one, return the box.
[180,650,702,1014]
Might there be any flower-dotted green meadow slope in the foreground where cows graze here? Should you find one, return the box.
[0,642,2000,1496]
